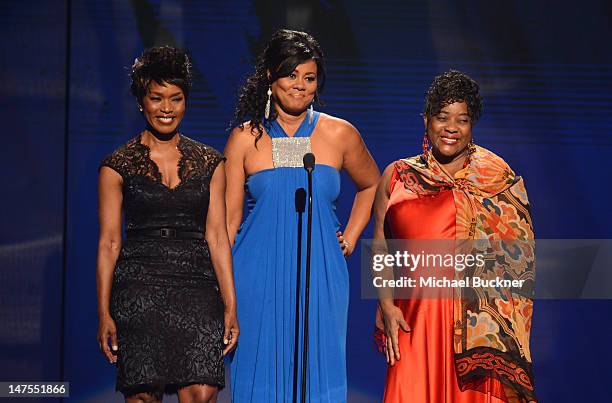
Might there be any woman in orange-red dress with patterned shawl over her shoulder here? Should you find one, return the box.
[374,70,536,403]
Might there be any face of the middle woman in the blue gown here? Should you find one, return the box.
[272,60,317,115]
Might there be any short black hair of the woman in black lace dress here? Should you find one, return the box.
[130,46,191,105]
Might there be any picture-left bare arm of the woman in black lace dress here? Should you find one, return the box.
[96,167,123,362]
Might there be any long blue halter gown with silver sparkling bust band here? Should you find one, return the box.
[231,112,349,403]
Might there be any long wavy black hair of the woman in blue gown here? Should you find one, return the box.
[230,29,325,146]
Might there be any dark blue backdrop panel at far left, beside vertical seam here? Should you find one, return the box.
[0,2,67,400]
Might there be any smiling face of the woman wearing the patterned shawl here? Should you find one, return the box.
[424,102,472,164]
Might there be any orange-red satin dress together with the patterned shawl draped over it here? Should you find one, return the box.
[377,147,535,403]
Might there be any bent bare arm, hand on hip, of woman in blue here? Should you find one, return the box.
[340,122,380,254]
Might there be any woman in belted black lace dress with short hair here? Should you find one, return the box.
[97,47,238,403]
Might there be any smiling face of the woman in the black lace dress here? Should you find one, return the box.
[142,81,185,135]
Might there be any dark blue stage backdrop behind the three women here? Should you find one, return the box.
[0,0,612,402]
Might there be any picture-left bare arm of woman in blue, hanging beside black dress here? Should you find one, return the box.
[224,128,248,245]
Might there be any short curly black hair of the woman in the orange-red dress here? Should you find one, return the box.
[423,70,482,124]
